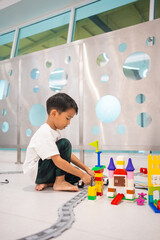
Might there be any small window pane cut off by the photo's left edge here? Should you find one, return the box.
[0,31,15,60]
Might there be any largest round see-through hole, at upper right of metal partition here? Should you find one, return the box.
[123,52,151,80]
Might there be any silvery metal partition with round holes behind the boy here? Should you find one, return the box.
[0,19,160,162]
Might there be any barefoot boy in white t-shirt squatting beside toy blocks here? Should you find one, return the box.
[23,93,94,191]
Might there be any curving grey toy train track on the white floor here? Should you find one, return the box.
[19,189,87,240]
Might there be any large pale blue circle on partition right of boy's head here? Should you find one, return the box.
[95,95,121,123]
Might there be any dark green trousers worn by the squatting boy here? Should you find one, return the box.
[36,138,80,184]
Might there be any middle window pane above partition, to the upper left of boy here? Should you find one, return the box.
[16,12,70,56]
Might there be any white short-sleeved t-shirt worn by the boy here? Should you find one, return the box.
[23,123,61,181]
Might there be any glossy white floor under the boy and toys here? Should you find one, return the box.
[0,151,160,240]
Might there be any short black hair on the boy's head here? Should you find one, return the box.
[46,93,78,114]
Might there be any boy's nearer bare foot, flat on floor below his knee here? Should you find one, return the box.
[53,180,79,192]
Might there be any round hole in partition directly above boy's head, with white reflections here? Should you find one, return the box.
[49,68,68,92]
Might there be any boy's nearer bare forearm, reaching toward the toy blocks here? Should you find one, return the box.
[51,155,91,185]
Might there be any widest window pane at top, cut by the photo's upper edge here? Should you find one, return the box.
[73,0,149,41]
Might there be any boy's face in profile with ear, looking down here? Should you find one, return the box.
[51,108,76,130]
